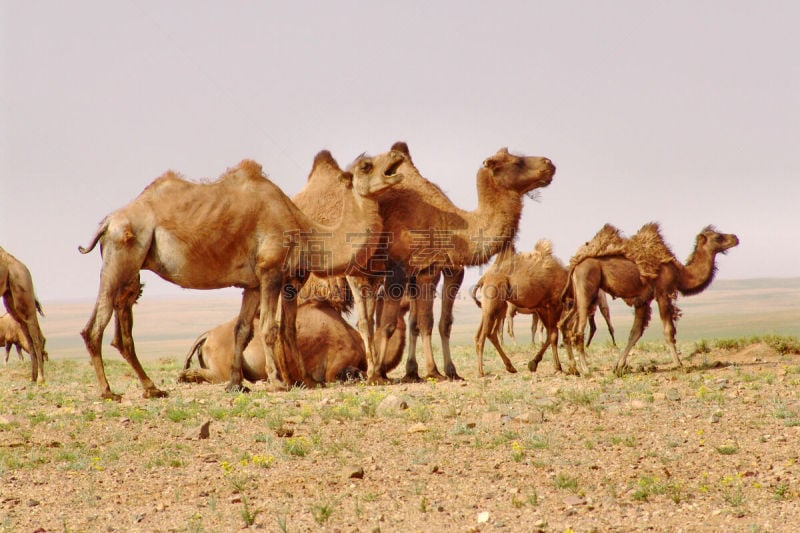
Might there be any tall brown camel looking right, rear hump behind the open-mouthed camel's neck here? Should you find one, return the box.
[294,142,555,383]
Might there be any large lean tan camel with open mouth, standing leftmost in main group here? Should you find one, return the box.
[79,151,404,400]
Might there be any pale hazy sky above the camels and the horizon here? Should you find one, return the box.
[0,0,800,303]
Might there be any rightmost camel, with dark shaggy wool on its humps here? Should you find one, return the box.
[562,223,739,376]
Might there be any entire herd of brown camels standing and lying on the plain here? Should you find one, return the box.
[0,142,739,400]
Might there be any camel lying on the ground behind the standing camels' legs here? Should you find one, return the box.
[178,299,405,383]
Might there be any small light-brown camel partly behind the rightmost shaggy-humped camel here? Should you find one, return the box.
[472,239,575,376]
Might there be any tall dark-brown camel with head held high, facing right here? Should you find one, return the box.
[371,142,555,381]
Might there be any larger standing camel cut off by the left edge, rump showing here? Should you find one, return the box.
[0,248,45,383]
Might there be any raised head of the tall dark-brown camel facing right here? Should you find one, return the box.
[481,148,556,195]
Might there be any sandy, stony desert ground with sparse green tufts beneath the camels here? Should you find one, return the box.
[0,280,800,532]
